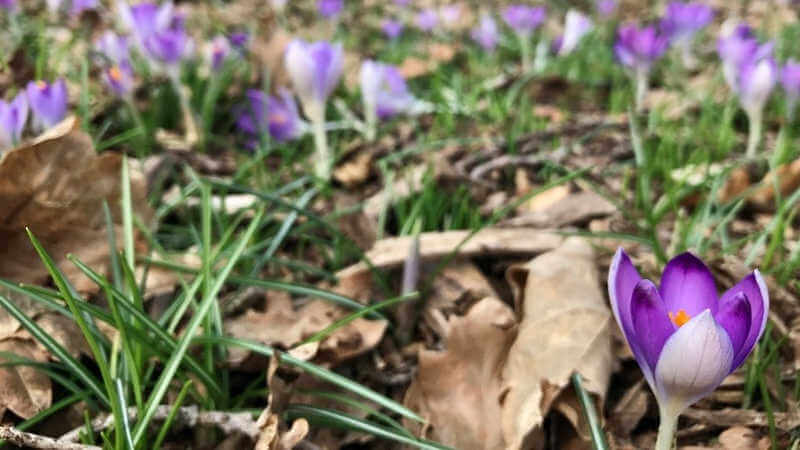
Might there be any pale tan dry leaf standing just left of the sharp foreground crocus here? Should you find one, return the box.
[502,238,613,449]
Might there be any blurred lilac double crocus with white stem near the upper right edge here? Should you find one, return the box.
[717,23,778,157]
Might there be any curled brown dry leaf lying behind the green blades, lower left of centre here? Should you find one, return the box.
[225,295,387,365]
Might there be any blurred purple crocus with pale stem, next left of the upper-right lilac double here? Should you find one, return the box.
[614,24,669,111]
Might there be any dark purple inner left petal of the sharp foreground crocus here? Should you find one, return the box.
[631,280,675,373]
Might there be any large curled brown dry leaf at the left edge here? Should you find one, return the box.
[0,118,150,292]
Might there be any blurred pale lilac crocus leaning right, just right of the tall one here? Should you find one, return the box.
[359,60,414,140]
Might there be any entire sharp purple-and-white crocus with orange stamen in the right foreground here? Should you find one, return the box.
[608,249,769,450]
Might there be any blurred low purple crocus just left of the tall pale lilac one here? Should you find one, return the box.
[236,89,306,142]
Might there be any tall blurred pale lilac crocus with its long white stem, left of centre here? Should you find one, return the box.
[284,39,344,181]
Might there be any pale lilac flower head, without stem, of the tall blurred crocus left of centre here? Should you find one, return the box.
[285,39,344,120]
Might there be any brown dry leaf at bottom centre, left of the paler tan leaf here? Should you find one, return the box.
[405,297,516,450]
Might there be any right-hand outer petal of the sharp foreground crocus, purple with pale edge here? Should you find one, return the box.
[720,270,769,370]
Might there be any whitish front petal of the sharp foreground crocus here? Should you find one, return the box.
[655,309,733,415]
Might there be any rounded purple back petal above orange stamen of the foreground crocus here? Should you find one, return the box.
[660,253,717,317]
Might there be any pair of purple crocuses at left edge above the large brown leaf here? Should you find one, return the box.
[0,79,67,149]
